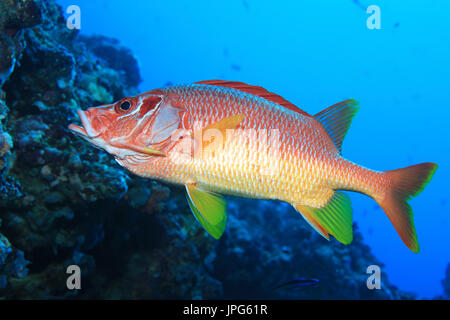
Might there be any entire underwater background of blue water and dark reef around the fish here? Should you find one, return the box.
[0,0,450,299]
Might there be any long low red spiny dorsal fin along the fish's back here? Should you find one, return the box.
[195,80,311,117]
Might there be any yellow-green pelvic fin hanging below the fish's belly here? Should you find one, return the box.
[186,185,227,239]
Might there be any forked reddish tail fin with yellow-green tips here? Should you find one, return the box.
[378,163,437,253]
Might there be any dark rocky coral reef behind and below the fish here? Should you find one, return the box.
[0,0,414,299]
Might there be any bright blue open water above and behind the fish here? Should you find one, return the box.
[58,0,450,298]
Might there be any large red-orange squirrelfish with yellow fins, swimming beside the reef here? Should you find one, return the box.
[69,80,437,252]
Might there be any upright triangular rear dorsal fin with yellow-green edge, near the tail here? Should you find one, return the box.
[314,99,359,153]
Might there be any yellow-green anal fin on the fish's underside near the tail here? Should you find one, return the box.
[293,191,353,244]
